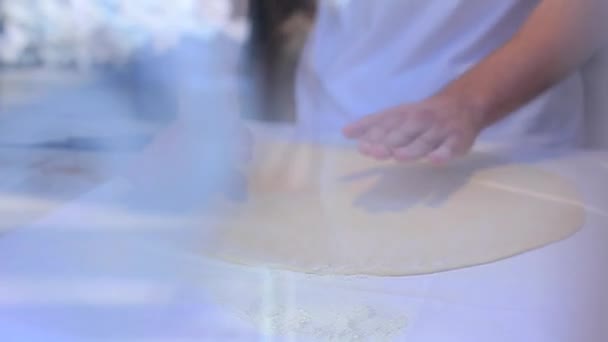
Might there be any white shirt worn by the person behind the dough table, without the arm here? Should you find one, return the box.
[296,0,584,146]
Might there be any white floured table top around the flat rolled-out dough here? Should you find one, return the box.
[0,150,608,341]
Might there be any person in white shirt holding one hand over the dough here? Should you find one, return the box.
[282,0,608,162]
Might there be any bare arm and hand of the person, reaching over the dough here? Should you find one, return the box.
[344,0,608,161]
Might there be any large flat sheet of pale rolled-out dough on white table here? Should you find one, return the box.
[204,142,584,275]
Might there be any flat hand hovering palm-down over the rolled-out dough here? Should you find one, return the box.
[344,96,483,163]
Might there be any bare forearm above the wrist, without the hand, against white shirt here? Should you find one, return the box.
[439,0,608,127]
